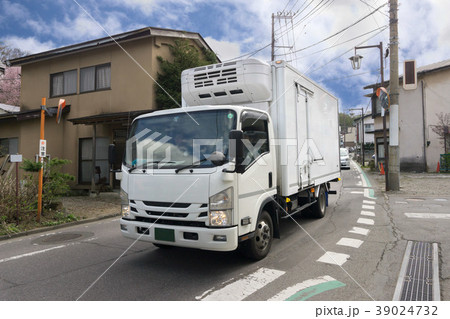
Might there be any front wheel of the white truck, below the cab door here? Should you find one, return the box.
[240,210,273,260]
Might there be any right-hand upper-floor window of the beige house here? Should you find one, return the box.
[80,63,111,93]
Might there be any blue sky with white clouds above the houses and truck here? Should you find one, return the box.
[0,0,450,112]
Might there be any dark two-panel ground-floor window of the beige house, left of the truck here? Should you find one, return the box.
[78,137,109,184]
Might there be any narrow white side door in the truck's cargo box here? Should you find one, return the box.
[295,83,311,188]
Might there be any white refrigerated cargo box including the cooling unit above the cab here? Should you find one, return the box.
[182,59,340,196]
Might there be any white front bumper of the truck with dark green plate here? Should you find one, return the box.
[120,218,238,251]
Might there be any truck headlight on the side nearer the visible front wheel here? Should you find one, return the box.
[209,187,233,227]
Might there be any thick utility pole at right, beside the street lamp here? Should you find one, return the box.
[387,0,400,191]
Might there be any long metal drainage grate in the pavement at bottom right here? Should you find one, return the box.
[394,241,440,301]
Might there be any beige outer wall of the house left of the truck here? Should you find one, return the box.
[0,37,204,186]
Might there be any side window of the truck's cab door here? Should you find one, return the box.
[242,113,269,166]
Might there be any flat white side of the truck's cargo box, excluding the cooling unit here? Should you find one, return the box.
[268,62,340,196]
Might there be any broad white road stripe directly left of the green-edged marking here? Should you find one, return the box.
[196,268,285,301]
